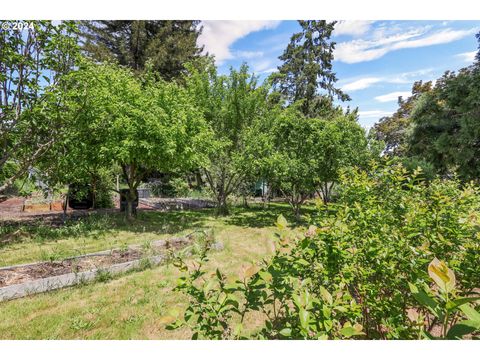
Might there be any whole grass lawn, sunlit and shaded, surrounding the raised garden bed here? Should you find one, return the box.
[0,204,313,339]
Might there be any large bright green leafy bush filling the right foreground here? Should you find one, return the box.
[167,164,480,339]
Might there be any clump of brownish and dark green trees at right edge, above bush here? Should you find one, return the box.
[371,34,480,181]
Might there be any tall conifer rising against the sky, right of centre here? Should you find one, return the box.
[272,20,350,117]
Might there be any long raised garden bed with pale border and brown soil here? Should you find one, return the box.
[0,234,199,301]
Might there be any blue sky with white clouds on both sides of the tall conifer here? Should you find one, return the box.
[199,20,480,128]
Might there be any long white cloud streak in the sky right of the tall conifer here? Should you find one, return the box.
[334,27,476,64]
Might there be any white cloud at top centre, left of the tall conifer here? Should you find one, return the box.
[197,20,280,64]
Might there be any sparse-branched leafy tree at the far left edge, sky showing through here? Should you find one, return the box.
[0,21,79,192]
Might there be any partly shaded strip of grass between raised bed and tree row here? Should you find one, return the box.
[0,203,313,266]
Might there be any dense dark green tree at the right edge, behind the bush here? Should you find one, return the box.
[408,66,480,180]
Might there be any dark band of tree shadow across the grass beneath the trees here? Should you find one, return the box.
[0,203,322,249]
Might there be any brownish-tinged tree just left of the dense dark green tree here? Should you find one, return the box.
[370,81,432,157]
